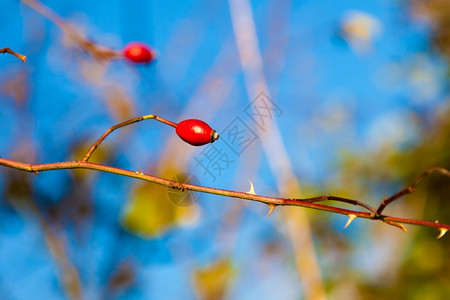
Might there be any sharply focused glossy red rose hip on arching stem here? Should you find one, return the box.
[176,119,219,146]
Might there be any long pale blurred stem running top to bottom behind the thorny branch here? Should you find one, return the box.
[228,0,327,300]
